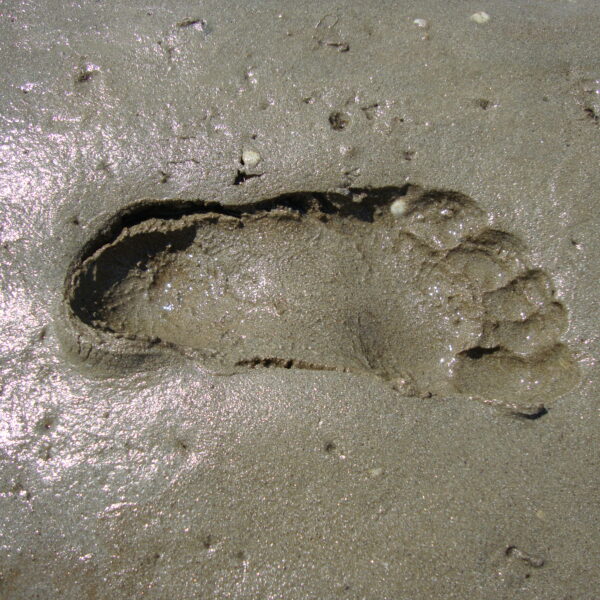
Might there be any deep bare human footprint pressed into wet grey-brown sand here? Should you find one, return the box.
[65,186,577,403]
